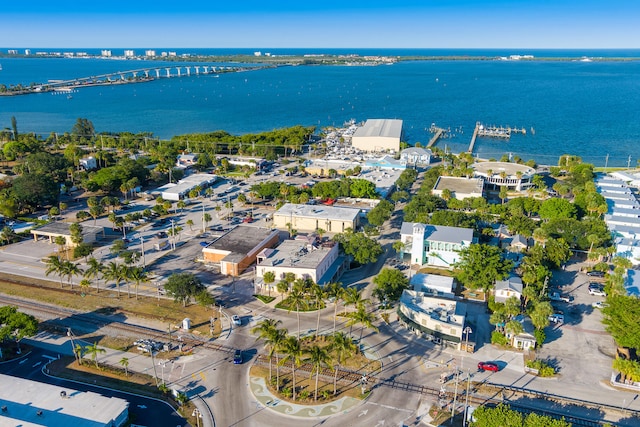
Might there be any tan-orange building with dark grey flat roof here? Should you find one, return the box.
[202,225,280,276]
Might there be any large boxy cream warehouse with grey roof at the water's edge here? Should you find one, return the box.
[351,119,402,151]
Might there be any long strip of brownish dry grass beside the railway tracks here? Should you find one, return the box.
[0,274,220,336]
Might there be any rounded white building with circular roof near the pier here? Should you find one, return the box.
[471,162,536,191]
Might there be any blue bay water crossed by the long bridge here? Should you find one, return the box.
[0,49,640,166]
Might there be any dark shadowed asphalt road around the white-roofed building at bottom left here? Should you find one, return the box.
[0,348,189,427]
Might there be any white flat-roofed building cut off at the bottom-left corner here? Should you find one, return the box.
[0,374,129,427]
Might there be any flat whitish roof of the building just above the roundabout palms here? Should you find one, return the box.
[258,240,332,269]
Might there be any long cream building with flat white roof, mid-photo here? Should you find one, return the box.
[273,203,360,233]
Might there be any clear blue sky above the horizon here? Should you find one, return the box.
[0,0,640,48]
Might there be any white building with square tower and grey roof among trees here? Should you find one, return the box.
[400,222,475,268]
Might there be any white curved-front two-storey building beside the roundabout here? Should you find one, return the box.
[398,289,467,350]
